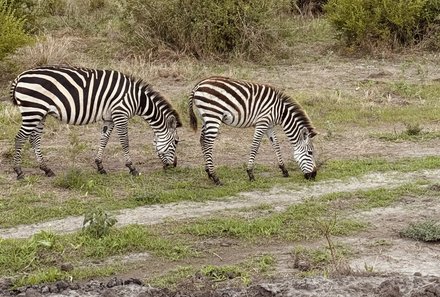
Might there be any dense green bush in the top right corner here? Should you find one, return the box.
[325,0,440,47]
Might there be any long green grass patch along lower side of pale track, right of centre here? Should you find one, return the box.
[174,183,438,241]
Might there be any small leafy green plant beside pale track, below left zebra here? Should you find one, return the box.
[83,209,117,238]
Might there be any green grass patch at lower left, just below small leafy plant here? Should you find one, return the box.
[0,225,194,283]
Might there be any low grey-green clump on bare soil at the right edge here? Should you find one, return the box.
[399,220,440,242]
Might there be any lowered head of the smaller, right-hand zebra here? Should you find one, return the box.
[293,127,317,179]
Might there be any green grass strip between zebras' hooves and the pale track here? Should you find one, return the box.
[0,157,440,227]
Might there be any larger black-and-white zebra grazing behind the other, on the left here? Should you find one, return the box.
[11,66,182,179]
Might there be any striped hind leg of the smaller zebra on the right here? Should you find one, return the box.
[200,122,222,186]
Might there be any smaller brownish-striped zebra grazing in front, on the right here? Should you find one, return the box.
[188,77,316,184]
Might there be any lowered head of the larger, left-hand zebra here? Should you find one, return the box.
[153,115,181,168]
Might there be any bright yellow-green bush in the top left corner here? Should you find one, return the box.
[0,0,32,60]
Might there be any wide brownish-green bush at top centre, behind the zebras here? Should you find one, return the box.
[124,0,277,58]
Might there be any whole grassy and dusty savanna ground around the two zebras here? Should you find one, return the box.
[0,13,440,296]
